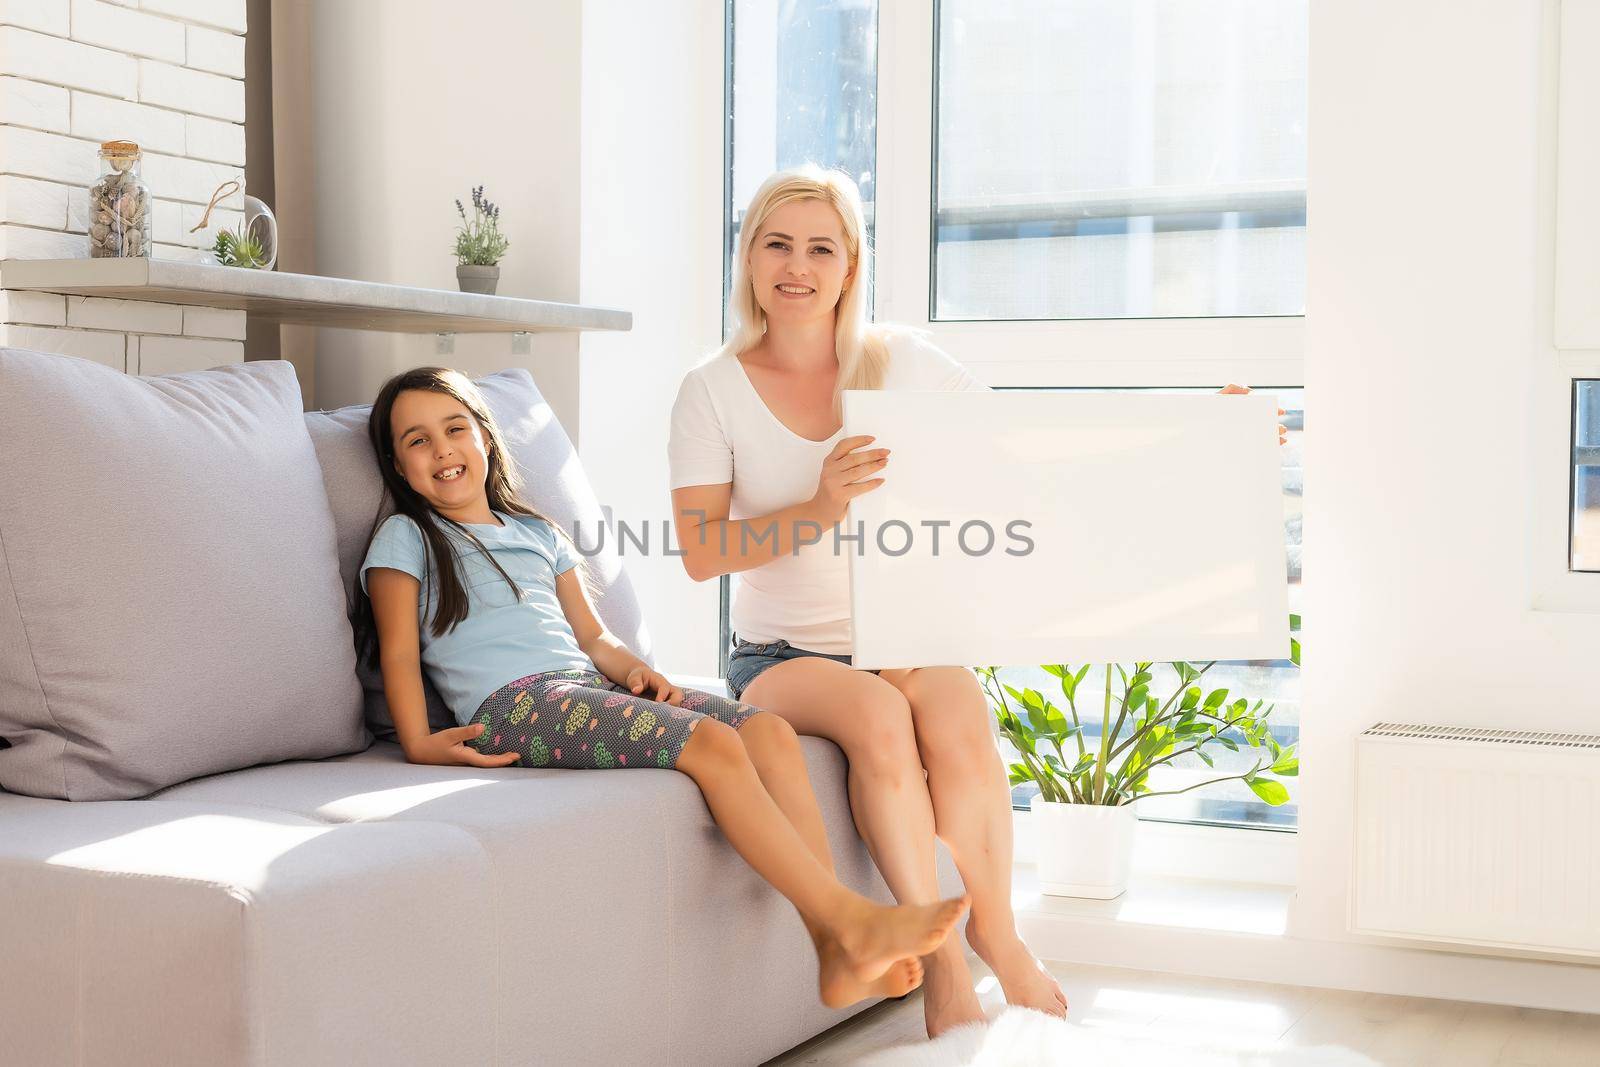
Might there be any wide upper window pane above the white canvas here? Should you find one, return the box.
[930,0,1307,320]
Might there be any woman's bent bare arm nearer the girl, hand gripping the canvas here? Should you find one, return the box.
[672,434,890,582]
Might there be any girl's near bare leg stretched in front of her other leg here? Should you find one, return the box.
[675,718,968,982]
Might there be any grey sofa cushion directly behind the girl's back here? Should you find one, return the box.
[306,366,654,741]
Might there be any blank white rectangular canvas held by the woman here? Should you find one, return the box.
[844,389,1290,669]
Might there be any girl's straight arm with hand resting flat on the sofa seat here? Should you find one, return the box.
[366,566,518,766]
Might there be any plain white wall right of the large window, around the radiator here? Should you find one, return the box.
[1293,0,1600,1006]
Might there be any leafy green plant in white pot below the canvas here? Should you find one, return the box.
[978,614,1301,899]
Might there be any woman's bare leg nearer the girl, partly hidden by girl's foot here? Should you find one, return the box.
[739,656,984,1037]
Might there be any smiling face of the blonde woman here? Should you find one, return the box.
[749,200,853,322]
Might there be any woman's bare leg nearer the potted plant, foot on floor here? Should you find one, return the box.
[883,667,1067,1017]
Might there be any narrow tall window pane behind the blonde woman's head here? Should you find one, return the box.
[722,0,878,333]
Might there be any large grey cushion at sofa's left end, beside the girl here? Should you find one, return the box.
[0,349,371,800]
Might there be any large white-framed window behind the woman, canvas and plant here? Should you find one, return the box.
[718,0,1305,829]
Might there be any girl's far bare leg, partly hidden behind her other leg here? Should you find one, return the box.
[739,712,922,1008]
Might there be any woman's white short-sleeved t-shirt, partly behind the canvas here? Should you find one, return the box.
[667,331,987,656]
